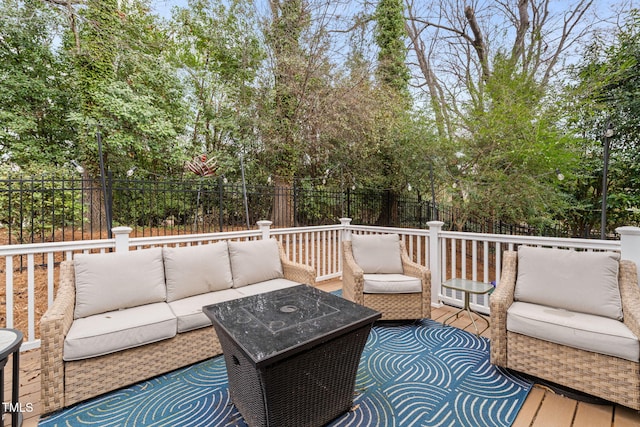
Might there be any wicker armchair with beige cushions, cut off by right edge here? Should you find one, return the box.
[490,246,640,410]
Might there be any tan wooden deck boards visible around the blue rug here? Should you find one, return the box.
[4,280,640,427]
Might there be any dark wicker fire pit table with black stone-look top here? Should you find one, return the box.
[203,285,380,427]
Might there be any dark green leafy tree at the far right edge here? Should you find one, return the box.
[566,10,640,236]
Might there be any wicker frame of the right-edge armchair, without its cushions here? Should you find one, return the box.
[490,248,640,410]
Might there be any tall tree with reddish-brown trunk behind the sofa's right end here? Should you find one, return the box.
[259,0,344,225]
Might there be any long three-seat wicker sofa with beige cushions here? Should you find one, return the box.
[40,239,315,413]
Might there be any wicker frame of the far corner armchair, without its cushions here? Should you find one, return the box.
[342,235,431,320]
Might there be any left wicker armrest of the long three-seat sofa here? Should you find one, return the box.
[40,261,75,413]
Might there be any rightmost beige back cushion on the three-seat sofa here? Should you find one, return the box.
[229,239,284,288]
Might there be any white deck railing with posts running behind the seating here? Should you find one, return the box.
[0,219,640,350]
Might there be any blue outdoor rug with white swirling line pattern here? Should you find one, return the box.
[39,320,532,427]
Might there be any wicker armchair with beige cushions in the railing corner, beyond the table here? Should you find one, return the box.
[342,234,431,320]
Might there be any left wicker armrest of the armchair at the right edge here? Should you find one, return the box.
[489,251,518,366]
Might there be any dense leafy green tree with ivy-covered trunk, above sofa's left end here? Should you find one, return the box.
[55,0,187,176]
